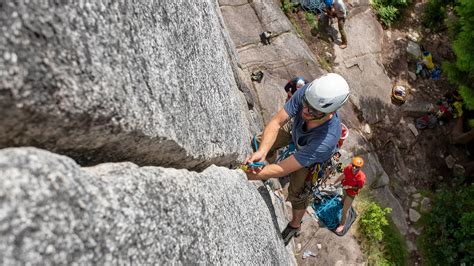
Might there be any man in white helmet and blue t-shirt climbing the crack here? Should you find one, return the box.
[245,73,349,245]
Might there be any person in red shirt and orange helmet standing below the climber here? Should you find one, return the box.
[334,156,365,233]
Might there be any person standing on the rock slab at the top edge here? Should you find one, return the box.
[321,0,347,49]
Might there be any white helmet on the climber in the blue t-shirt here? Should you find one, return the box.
[305,73,349,113]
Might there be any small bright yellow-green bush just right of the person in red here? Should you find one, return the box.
[359,202,392,242]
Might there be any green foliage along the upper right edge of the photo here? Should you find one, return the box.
[443,0,474,110]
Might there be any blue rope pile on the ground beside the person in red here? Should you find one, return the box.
[313,195,342,230]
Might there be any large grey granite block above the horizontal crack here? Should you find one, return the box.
[0,0,249,169]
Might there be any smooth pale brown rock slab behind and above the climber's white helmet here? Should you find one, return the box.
[219,0,324,124]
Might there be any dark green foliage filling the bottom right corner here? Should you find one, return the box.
[420,184,474,265]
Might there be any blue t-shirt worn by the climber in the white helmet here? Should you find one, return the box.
[284,85,342,167]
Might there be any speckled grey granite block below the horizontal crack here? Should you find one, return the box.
[0,148,293,265]
